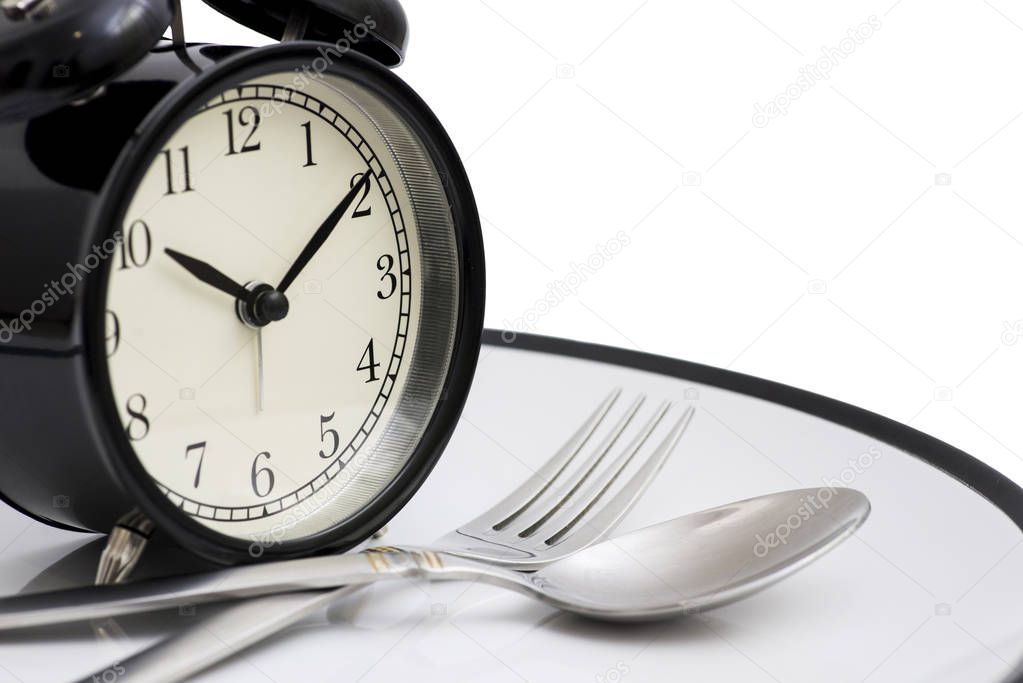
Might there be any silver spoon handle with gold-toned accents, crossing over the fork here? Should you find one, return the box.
[0,548,452,631]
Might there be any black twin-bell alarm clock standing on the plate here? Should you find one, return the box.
[0,0,484,571]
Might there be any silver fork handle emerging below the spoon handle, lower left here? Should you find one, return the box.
[75,586,363,683]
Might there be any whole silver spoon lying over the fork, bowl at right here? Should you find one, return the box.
[0,489,871,630]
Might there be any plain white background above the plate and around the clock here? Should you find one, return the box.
[184,0,1023,482]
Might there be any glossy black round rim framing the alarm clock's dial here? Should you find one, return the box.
[80,42,485,564]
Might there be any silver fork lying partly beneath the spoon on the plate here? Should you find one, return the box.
[82,390,695,683]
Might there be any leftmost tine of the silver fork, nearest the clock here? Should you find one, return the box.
[464,389,622,531]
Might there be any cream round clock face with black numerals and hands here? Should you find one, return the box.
[105,73,458,544]
